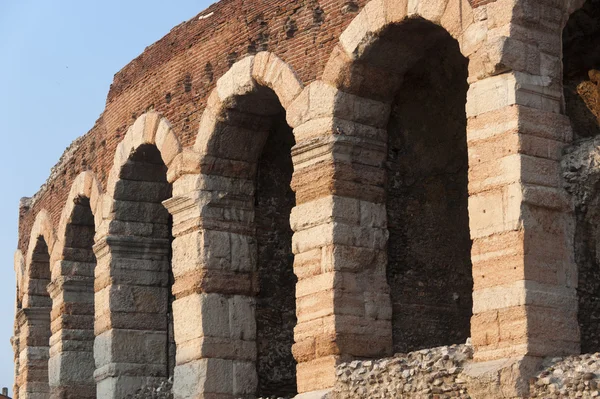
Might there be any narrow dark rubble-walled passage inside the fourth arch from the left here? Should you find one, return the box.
[255,97,297,396]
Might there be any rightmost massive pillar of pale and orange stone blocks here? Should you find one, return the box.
[467,72,579,395]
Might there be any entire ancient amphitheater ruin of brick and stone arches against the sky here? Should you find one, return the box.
[12,0,600,399]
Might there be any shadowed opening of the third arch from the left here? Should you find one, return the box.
[110,144,176,382]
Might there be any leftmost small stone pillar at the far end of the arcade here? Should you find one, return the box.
[17,307,50,399]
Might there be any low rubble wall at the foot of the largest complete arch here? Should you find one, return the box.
[333,344,473,399]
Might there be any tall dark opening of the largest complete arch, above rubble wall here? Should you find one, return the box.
[351,18,473,352]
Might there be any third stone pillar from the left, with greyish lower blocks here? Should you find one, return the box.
[94,236,170,399]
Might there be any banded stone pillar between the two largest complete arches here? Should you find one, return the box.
[288,83,392,393]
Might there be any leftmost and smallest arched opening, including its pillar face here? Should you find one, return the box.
[19,236,52,397]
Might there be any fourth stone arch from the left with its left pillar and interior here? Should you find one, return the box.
[168,52,303,398]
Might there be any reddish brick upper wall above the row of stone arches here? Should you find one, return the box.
[19,0,367,253]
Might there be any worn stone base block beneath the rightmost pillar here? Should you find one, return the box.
[463,356,543,399]
